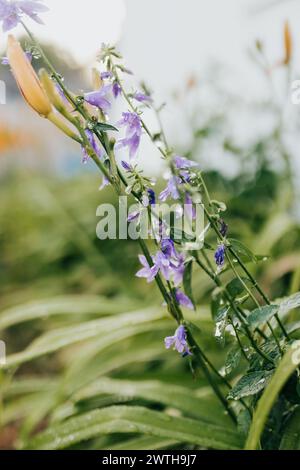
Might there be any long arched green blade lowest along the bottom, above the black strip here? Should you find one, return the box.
[28,406,242,450]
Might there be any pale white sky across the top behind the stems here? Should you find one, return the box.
[0,0,300,178]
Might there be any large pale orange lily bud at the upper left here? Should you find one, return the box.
[7,35,52,117]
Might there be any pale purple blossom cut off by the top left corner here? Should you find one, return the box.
[0,0,48,32]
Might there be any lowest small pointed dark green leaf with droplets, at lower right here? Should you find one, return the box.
[228,370,273,400]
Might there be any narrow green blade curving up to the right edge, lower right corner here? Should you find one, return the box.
[245,341,300,450]
